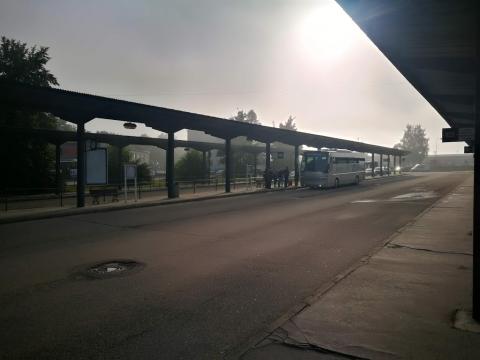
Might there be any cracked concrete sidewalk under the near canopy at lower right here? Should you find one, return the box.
[246,179,480,360]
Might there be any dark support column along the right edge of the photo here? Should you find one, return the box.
[472,16,480,322]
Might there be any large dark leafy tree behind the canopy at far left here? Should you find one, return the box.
[0,36,58,189]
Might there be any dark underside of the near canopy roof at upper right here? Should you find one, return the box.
[337,0,478,143]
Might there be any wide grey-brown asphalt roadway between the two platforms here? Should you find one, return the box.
[0,173,470,359]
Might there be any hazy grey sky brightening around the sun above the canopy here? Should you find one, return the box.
[0,0,464,153]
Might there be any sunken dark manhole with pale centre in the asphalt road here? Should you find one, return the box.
[74,260,145,279]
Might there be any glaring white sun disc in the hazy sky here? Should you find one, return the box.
[300,5,355,59]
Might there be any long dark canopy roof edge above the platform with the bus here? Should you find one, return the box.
[0,81,407,156]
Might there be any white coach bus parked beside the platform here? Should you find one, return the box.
[300,148,365,188]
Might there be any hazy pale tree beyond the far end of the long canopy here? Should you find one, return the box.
[394,124,429,165]
